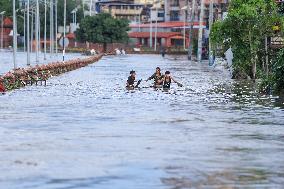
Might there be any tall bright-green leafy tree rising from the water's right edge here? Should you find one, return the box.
[210,0,282,79]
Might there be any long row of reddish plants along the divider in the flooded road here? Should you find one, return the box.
[0,54,103,92]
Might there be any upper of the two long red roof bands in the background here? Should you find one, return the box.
[130,21,206,28]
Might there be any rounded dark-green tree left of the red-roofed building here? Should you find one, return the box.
[76,13,130,51]
